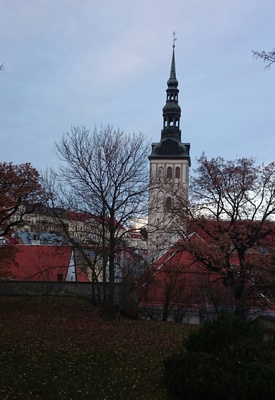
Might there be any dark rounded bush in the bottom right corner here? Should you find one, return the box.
[164,314,275,400]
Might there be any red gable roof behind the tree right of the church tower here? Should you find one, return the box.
[139,233,274,309]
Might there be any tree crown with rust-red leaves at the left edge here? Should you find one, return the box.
[0,162,44,236]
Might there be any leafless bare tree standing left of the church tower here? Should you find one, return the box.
[48,126,149,309]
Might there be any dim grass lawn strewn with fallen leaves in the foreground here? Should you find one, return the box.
[0,297,195,400]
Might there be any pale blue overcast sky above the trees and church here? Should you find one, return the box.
[0,0,275,171]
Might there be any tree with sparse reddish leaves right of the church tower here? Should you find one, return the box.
[174,154,275,314]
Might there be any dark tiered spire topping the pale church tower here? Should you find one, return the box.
[149,33,190,164]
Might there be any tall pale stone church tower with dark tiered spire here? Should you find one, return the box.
[148,38,191,259]
